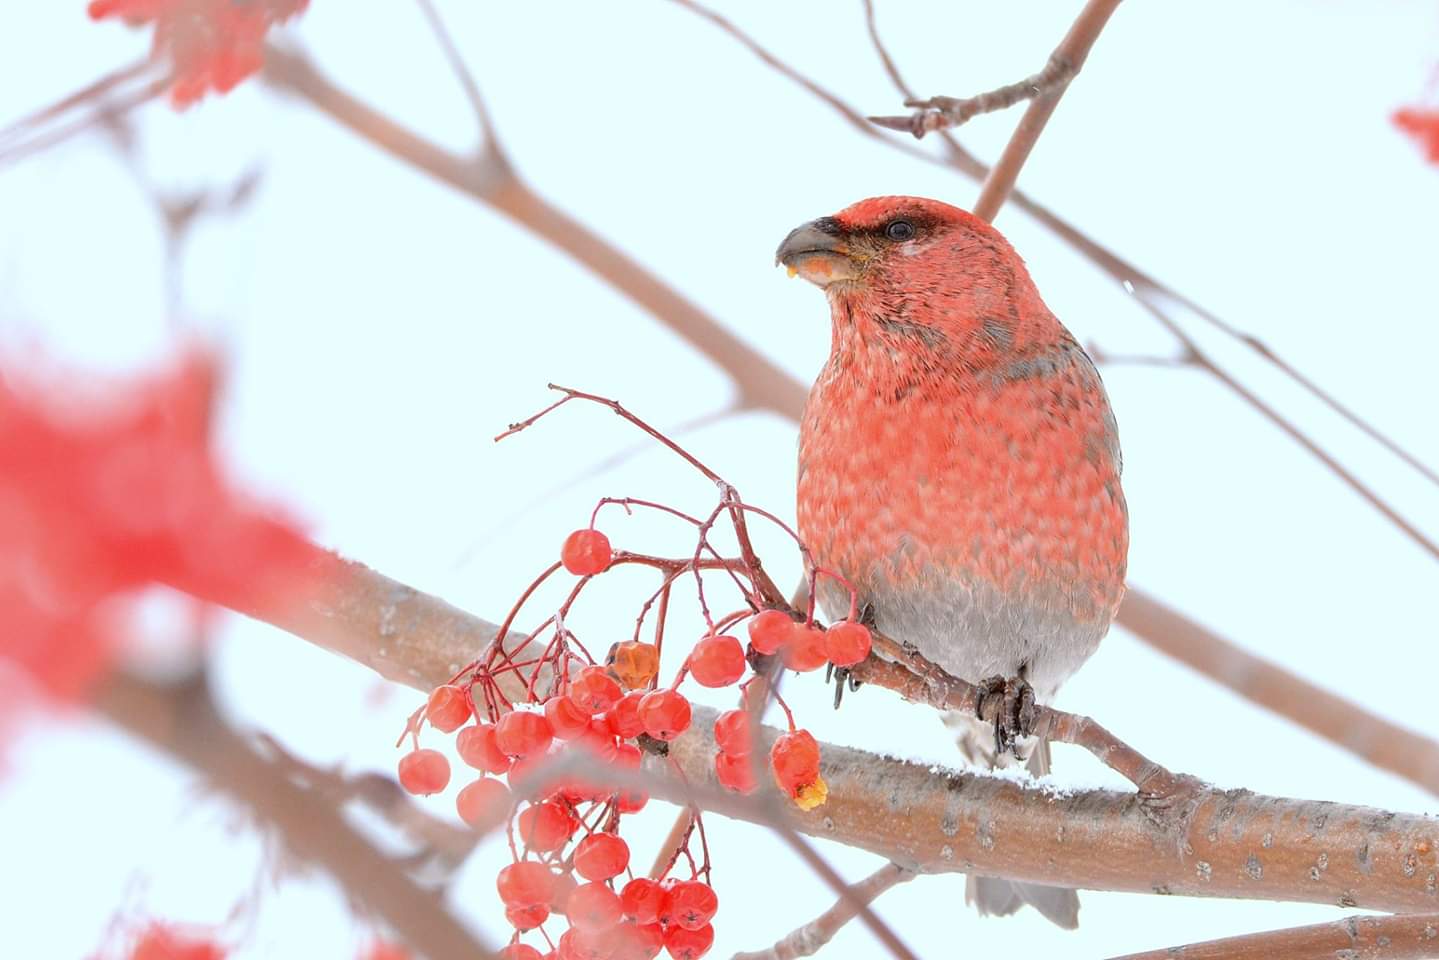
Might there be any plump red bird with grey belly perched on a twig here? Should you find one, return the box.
[777,197,1128,927]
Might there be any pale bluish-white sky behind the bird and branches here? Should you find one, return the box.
[0,0,1439,957]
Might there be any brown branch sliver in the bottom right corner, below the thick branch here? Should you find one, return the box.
[1114,914,1439,960]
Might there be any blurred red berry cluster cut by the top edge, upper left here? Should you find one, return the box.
[89,0,309,107]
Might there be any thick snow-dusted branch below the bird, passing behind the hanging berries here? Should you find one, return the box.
[182,548,1439,911]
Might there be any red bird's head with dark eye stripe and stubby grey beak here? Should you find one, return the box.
[774,197,1009,292]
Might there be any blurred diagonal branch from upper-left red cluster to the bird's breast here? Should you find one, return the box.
[263,47,807,413]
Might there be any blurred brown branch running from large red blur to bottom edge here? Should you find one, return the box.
[95,674,494,960]
